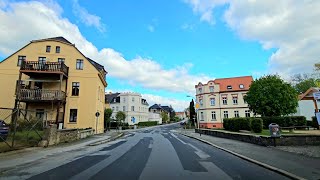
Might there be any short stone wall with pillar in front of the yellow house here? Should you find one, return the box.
[39,125,94,146]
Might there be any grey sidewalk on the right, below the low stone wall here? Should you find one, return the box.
[177,129,320,180]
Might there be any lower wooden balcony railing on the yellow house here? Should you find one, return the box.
[17,89,66,101]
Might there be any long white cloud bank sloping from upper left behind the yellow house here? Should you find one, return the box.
[0,1,211,94]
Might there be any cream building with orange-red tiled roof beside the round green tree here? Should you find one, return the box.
[195,76,253,128]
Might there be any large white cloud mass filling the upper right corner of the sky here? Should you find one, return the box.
[185,0,320,78]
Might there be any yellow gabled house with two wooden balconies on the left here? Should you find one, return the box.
[0,37,107,133]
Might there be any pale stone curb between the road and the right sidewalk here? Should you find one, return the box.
[180,133,306,180]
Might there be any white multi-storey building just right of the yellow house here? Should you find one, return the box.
[106,92,149,125]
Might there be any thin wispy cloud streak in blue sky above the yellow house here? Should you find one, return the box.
[72,0,106,33]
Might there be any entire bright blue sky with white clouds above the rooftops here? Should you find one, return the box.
[0,0,320,111]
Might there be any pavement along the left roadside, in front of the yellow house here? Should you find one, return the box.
[0,131,120,172]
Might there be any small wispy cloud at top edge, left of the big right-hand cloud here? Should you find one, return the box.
[184,0,228,25]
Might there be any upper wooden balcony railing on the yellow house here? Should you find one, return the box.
[20,61,69,75]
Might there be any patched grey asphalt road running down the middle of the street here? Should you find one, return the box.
[10,124,286,180]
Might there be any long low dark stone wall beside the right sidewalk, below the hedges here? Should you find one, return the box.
[195,129,320,146]
